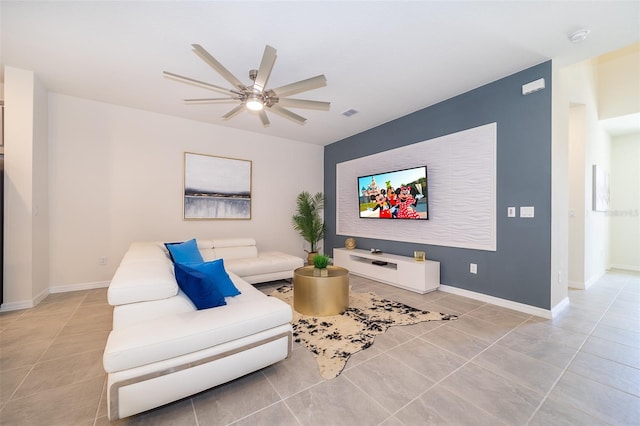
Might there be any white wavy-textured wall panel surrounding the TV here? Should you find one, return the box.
[336,123,497,251]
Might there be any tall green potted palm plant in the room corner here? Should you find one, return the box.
[291,191,327,264]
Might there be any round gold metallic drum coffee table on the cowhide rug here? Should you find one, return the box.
[293,266,349,317]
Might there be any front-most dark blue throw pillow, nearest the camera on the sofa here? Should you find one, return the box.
[173,262,227,310]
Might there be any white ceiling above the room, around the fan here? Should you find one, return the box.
[0,0,640,145]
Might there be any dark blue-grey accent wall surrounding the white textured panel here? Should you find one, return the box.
[324,61,552,309]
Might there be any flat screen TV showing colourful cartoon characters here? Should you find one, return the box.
[358,166,429,220]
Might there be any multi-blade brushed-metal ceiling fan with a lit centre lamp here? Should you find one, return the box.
[163,44,331,127]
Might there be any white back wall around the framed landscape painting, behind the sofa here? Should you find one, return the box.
[5,93,323,303]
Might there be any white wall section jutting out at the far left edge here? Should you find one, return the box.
[3,67,49,308]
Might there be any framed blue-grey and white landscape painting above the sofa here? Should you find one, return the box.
[183,152,252,220]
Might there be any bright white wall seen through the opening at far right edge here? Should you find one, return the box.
[609,133,640,271]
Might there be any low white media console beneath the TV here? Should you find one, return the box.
[333,248,440,294]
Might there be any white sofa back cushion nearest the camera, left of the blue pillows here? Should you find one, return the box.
[107,255,178,306]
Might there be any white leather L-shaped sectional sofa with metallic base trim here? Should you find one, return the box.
[103,239,303,420]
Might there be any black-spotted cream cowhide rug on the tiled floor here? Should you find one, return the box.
[270,286,458,379]
